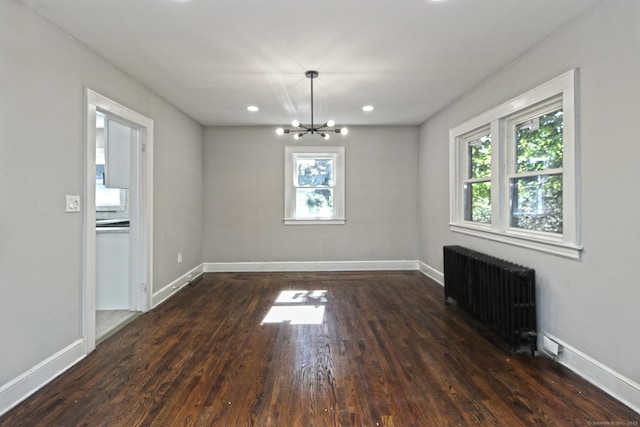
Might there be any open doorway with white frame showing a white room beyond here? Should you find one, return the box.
[83,89,153,353]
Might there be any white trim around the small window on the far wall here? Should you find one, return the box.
[284,146,346,225]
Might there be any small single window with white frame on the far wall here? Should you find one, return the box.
[284,146,345,224]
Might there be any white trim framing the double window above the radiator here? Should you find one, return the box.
[449,69,582,260]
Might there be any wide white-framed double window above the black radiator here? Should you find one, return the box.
[449,70,582,259]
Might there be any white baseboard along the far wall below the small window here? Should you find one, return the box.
[204,260,418,273]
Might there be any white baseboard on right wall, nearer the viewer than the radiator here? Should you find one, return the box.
[538,331,640,413]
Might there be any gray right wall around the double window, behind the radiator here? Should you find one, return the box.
[419,0,640,383]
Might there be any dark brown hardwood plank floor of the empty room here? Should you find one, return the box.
[0,272,640,427]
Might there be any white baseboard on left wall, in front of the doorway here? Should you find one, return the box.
[0,339,86,415]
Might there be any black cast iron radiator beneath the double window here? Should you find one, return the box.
[444,246,537,355]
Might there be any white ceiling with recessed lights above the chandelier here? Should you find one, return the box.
[21,0,601,125]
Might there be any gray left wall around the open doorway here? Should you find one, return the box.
[0,0,203,388]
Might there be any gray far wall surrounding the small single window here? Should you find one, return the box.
[204,127,418,262]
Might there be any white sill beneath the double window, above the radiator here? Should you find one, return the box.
[449,224,583,261]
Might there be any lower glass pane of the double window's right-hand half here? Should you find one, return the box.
[511,175,562,234]
